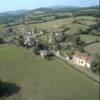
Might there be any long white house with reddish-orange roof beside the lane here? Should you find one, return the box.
[72,53,94,68]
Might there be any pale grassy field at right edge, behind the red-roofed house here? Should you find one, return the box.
[85,43,100,56]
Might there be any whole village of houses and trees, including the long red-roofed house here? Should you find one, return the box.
[15,27,95,68]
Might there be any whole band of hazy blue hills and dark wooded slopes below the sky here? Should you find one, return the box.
[0,6,100,24]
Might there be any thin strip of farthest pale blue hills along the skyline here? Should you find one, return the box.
[0,6,99,16]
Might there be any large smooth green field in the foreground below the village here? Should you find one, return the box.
[0,45,99,100]
